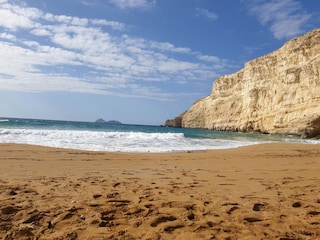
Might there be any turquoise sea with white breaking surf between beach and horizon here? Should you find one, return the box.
[0,118,320,153]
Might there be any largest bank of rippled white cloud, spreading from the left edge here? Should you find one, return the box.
[0,0,228,100]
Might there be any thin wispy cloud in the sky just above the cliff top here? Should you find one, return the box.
[246,0,313,39]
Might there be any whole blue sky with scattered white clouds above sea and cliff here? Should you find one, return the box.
[0,0,320,125]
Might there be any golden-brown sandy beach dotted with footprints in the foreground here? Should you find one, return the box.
[0,143,320,240]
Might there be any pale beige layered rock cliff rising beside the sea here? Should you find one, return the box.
[181,28,320,137]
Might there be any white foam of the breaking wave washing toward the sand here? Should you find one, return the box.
[0,128,261,152]
